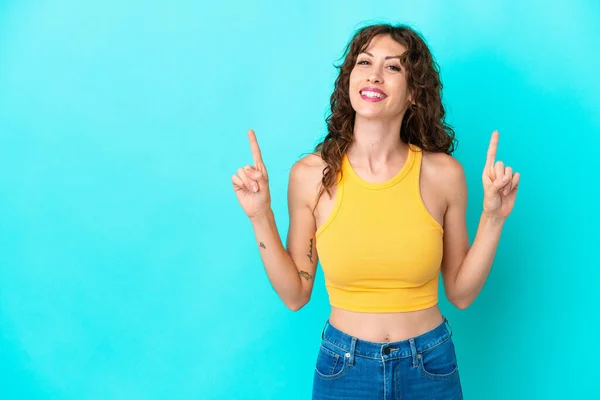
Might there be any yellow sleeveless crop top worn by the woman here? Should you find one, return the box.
[316,145,444,312]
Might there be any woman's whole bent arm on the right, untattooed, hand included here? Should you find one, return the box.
[442,131,520,309]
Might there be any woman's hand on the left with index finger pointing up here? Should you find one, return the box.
[231,129,271,218]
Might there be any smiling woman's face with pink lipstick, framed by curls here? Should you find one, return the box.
[350,35,411,119]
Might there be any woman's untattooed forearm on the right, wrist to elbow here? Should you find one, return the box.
[452,212,505,308]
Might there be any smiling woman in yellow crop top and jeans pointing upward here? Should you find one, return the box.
[232,24,519,400]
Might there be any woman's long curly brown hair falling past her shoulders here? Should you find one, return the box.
[315,24,457,207]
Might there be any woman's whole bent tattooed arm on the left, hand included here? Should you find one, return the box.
[233,132,318,311]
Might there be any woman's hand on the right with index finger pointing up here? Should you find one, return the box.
[482,131,521,218]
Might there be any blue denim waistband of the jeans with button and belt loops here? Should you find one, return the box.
[321,316,452,359]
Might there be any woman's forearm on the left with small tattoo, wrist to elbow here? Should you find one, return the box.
[250,210,306,310]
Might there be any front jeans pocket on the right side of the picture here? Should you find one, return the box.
[417,338,458,380]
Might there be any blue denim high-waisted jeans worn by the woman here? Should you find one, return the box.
[312,317,463,400]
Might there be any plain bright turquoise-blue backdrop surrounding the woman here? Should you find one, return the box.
[0,0,600,400]
